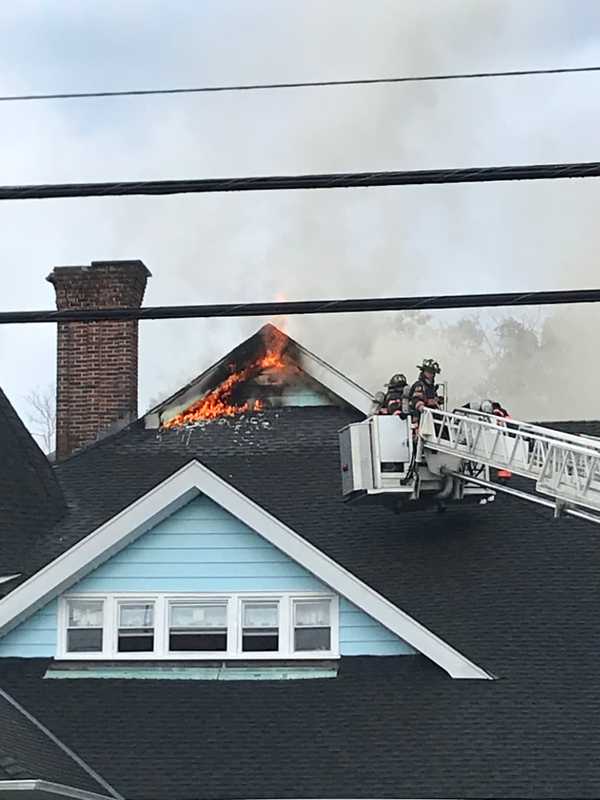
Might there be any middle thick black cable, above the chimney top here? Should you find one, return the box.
[0,161,600,200]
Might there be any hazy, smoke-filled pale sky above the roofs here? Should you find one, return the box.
[0,0,600,438]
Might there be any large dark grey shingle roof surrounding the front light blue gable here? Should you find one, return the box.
[0,384,600,800]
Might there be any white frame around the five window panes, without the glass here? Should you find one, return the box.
[56,592,340,661]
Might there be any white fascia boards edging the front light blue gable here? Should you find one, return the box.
[0,461,491,680]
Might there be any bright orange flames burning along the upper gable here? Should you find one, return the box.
[163,336,286,428]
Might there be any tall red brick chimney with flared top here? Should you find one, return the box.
[47,261,151,460]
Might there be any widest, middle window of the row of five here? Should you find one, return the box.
[169,603,227,652]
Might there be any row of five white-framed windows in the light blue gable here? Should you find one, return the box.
[57,592,339,662]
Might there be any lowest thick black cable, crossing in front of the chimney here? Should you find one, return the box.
[0,289,600,325]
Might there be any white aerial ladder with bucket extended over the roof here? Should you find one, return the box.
[340,408,600,523]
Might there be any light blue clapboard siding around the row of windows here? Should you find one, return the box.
[0,497,414,658]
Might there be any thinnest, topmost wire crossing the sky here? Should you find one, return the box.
[0,66,600,103]
